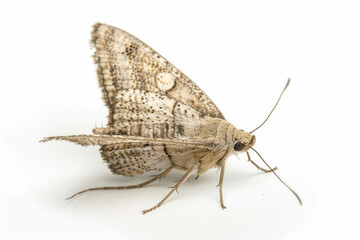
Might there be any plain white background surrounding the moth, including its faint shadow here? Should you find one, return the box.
[0,0,360,240]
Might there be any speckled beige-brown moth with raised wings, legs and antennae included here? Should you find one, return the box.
[42,23,301,214]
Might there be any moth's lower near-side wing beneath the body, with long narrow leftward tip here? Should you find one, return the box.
[42,135,215,176]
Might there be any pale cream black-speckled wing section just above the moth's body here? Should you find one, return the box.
[93,89,207,139]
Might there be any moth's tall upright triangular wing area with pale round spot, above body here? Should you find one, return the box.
[91,23,224,137]
